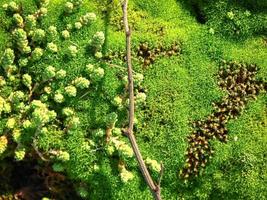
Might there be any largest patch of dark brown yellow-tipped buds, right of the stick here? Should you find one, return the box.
[180,61,266,179]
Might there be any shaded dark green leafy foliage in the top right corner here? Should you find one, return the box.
[181,0,267,40]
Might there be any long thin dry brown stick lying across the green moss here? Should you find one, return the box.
[122,0,163,200]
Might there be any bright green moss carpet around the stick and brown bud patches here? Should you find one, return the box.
[0,0,267,200]
